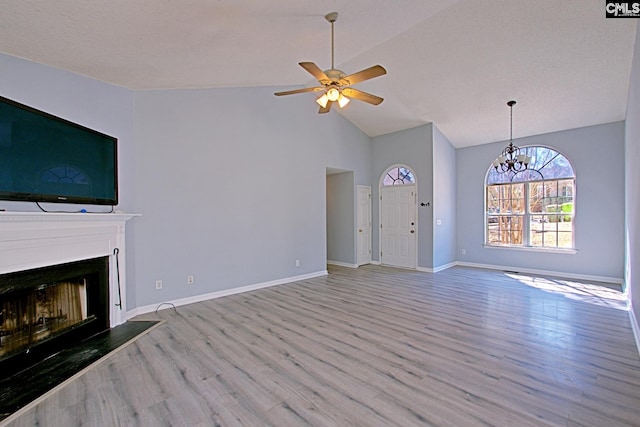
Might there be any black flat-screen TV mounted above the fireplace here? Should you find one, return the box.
[0,96,118,205]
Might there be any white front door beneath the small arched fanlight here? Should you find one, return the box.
[380,185,417,268]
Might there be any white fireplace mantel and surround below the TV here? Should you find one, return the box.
[0,212,138,327]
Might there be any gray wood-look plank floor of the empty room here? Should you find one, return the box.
[2,266,640,427]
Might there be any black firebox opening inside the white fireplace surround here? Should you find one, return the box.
[0,257,110,377]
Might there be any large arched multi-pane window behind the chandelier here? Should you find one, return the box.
[485,146,575,249]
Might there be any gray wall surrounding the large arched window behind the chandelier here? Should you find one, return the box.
[456,122,624,279]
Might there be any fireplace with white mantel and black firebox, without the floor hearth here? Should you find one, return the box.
[0,212,138,370]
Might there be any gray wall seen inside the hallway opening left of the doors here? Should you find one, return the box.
[327,172,356,265]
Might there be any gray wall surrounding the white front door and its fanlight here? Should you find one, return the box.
[371,124,433,269]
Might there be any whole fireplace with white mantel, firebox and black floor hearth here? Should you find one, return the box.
[0,211,140,424]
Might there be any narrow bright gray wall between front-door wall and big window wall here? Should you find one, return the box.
[432,126,456,269]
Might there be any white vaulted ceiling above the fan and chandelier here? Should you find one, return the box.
[0,0,637,147]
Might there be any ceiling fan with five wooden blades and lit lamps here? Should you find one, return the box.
[275,12,387,114]
